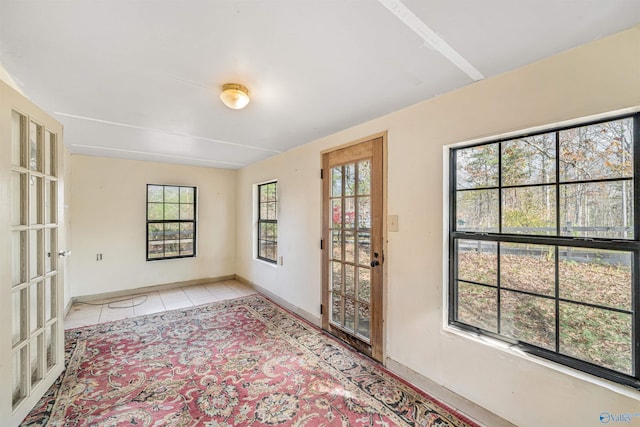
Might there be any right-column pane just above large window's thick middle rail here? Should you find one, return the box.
[560,181,633,239]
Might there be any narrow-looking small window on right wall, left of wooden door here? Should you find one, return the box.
[258,182,278,264]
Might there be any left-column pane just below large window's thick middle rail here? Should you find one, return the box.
[456,240,498,285]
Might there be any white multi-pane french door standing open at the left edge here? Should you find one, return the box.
[0,81,66,426]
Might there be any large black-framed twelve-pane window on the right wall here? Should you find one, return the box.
[449,114,640,388]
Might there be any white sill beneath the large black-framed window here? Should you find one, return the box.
[443,325,640,400]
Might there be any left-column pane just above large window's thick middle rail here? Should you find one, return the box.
[456,190,499,232]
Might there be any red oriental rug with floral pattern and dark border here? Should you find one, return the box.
[23,296,476,427]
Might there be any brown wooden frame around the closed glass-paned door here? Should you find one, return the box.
[320,131,388,365]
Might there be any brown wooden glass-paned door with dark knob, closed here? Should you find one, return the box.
[322,137,384,361]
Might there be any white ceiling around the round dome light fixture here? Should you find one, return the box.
[0,0,640,168]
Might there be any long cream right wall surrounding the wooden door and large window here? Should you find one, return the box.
[236,27,640,427]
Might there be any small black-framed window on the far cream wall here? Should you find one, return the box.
[147,184,196,261]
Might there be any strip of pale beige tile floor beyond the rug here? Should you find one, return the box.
[64,280,256,329]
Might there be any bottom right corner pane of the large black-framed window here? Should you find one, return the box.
[560,302,633,375]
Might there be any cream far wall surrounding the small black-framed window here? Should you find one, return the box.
[70,155,236,297]
